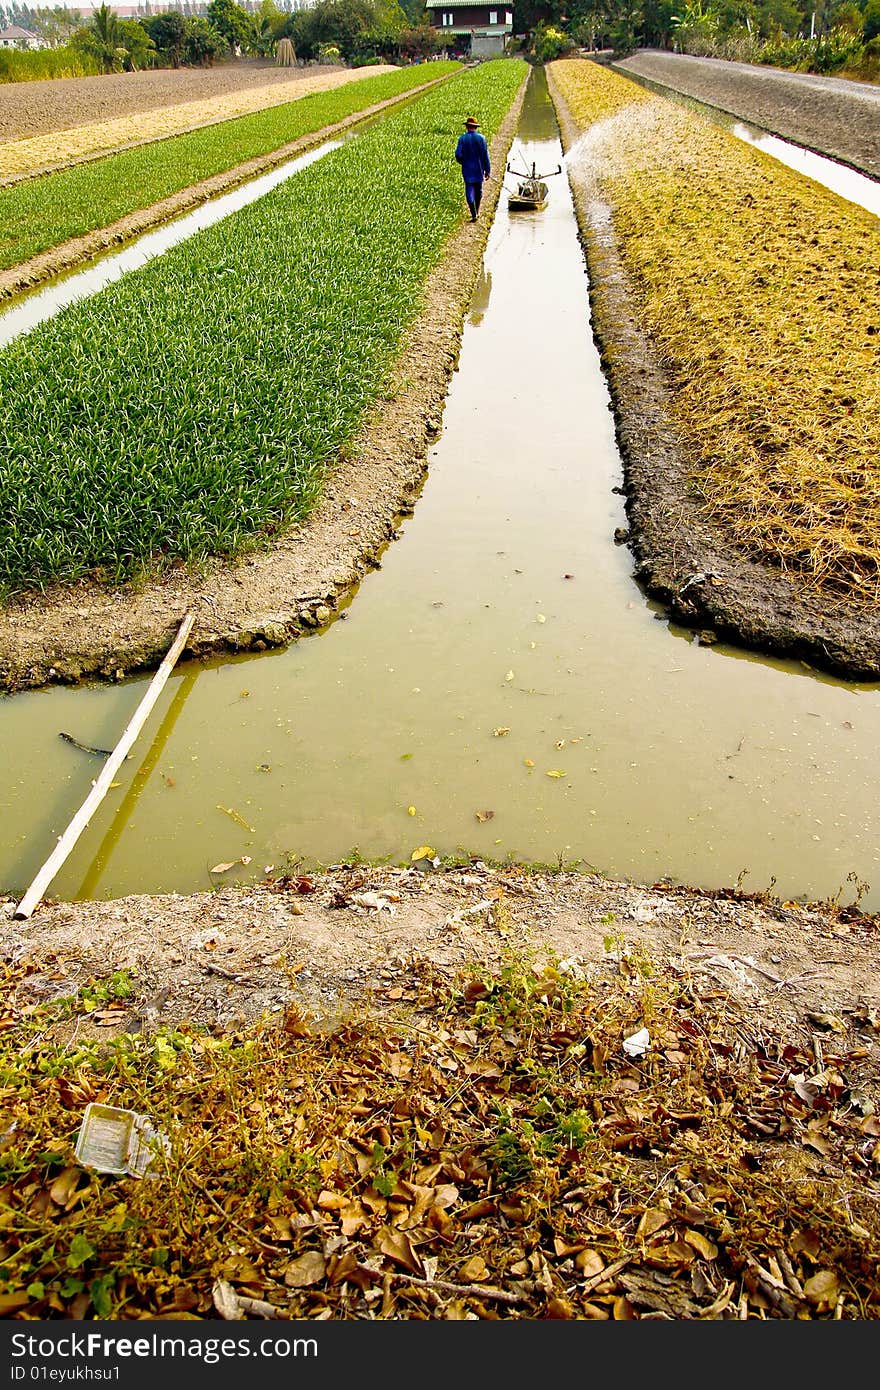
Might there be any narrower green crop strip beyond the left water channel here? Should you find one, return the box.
[0,63,459,270]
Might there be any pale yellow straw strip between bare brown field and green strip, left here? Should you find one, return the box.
[0,65,392,181]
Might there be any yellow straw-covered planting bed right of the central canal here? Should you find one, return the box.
[553,61,880,602]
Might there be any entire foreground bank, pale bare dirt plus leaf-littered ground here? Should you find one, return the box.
[6,860,880,1322]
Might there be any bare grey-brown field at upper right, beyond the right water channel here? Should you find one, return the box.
[614,50,880,178]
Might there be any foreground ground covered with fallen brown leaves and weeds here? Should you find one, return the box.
[0,940,880,1321]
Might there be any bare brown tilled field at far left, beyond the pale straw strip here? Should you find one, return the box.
[0,60,345,142]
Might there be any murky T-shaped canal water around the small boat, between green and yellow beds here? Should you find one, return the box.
[0,67,880,906]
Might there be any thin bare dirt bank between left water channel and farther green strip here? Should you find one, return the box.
[0,79,442,302]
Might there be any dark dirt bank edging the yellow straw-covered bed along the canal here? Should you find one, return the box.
[548,71,880,680]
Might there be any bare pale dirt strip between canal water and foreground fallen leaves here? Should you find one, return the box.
[0,862,880,1072]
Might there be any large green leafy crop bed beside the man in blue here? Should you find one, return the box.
[0,60,525,591]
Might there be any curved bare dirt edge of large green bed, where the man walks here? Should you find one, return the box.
[0,83,525,689]
